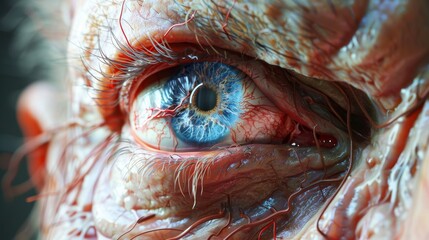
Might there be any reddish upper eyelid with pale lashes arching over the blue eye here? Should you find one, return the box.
[84,30,368,150]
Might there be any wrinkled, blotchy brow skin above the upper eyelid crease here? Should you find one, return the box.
[70,0,429,110]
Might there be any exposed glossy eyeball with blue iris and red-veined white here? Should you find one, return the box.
[130,61,294,151]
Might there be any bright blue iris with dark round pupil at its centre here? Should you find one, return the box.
[162,62,245,145]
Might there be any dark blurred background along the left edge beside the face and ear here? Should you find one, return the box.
[0,0,36,240]
